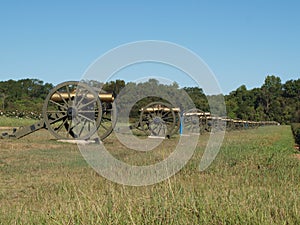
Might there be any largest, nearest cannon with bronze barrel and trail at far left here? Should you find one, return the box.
[0,81,116,140]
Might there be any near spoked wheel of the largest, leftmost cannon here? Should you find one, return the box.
[43,81,102,139]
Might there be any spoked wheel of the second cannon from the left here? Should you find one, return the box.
[139,102,180,137]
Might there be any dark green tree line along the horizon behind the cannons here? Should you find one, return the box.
[0,75,300,124]
